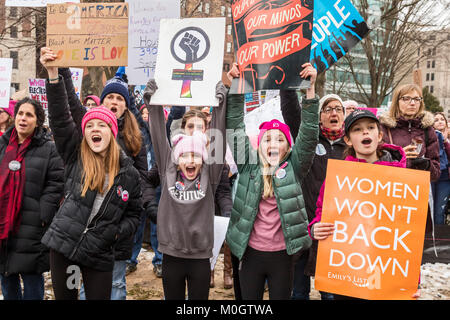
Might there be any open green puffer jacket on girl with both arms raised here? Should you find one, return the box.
[226,92,319,260]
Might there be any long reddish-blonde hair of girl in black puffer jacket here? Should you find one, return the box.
[80,133,120,197]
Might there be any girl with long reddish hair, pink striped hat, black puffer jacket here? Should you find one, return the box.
[40,50,143,300]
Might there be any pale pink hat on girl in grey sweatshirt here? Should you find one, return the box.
[172,131,208,162]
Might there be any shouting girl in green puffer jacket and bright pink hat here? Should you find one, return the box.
[226,63,319,300]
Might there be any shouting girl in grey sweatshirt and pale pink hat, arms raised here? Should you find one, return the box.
[144,80,228,300]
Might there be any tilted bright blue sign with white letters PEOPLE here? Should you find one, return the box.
[310,0,369,73]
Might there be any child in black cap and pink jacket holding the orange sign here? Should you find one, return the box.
[308,110,419,300]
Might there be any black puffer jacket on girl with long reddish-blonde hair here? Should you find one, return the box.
[42,77,143,271]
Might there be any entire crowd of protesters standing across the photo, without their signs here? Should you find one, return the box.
[0,48,450,300]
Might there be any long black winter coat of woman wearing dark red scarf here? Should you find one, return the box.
[0,127,64,275]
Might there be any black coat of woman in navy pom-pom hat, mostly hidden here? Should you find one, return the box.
[58,68,151,260]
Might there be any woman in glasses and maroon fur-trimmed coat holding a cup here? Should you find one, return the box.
[380,84,441,181]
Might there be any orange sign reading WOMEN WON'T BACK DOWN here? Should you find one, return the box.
[315,160,430,300]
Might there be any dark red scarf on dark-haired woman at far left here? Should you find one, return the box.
[0,128,33,248]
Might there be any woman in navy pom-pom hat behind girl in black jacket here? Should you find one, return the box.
[41,47,154,300]
